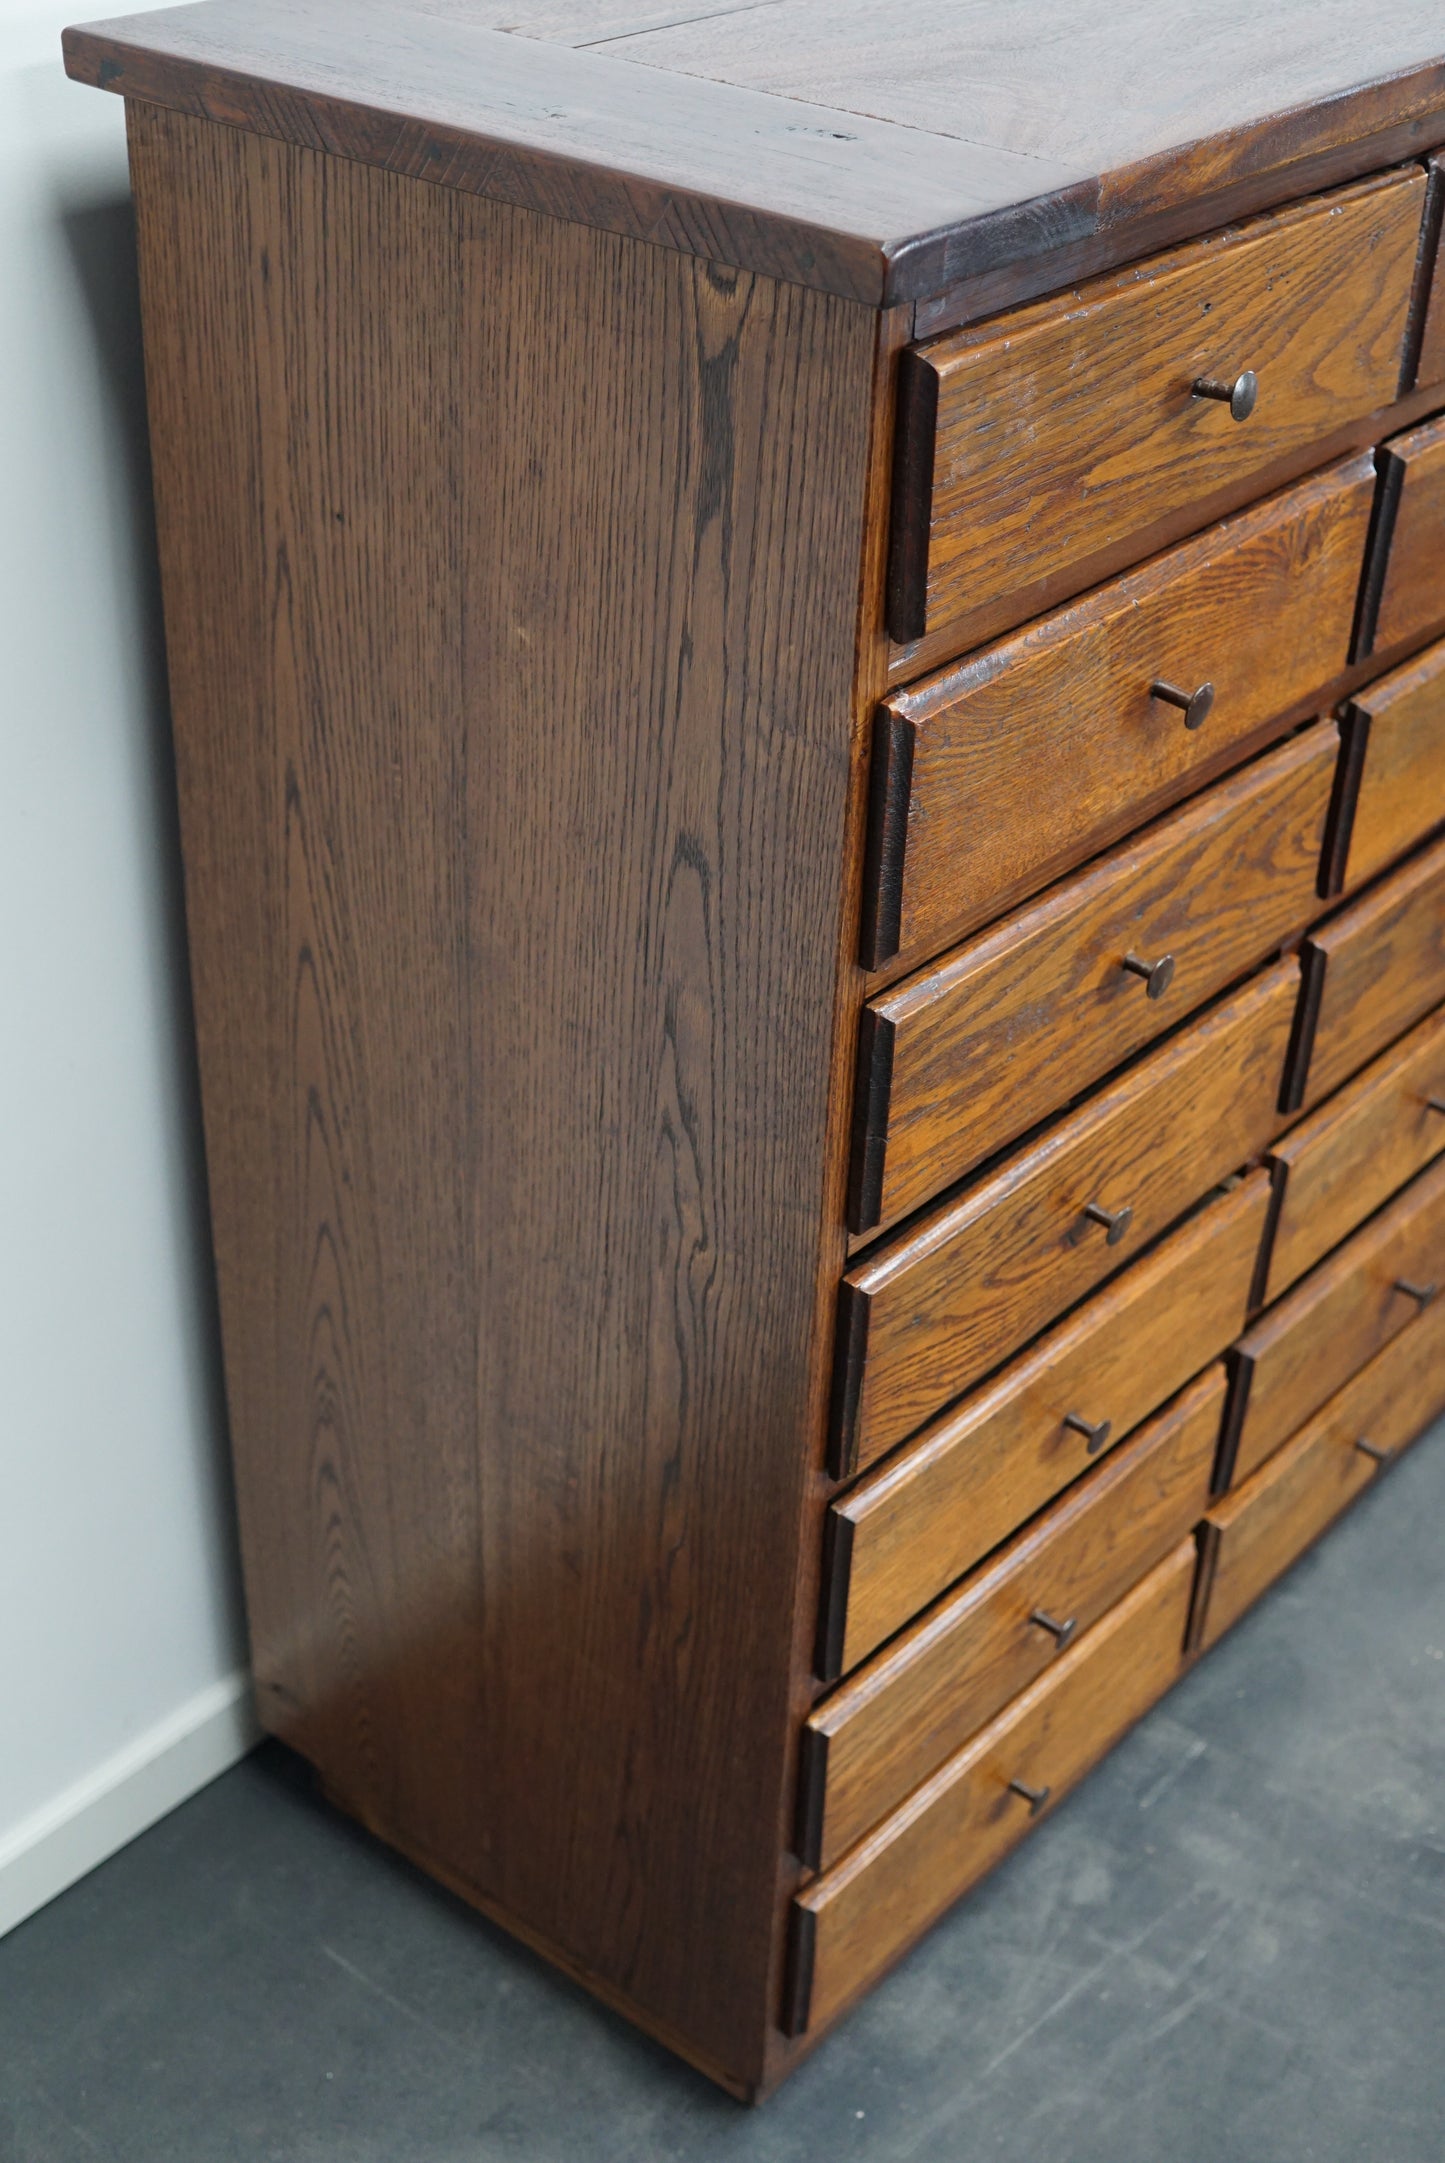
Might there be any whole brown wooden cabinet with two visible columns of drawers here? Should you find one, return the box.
[65,0,1445,2098]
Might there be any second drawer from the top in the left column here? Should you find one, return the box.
[863,454,1374,969]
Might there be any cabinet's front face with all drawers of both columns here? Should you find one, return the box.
[785,167,1445,2035]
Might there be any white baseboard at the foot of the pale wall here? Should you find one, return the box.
[0,1670,260,1938]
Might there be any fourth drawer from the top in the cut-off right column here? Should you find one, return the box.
[1281,821,1445,1112]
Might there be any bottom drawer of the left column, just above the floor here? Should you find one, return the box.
[783,1540,1194,2035]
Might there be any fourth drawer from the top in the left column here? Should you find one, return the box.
[833,960,1298,1462]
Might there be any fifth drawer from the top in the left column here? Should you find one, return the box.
[818,1172,1270,1643]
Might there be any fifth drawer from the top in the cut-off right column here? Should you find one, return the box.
[1265,1012,1445,1300]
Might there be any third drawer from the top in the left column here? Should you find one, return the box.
[850,720,1339,1231]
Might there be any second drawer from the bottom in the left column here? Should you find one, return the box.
[798,1365,1224,1867]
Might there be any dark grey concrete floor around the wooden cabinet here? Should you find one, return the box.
[0,1425,1445,2163]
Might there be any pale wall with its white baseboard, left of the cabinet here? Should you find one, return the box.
[0,0,251,1929]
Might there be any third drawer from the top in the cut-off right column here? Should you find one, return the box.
[1326,631,1445,893]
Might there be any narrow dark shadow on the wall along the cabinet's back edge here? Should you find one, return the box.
[58,195,240,1629]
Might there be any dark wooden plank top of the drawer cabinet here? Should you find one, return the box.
[65,0,1445,305]
